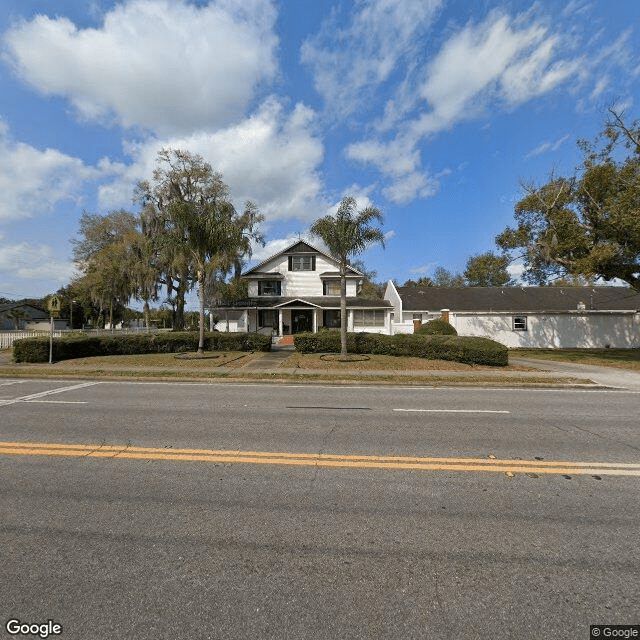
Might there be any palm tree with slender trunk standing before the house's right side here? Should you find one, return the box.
[311,196,384,358]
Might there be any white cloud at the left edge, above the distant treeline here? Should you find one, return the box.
[0,127,101,220]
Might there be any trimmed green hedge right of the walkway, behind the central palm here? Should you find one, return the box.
[294,331,509,367]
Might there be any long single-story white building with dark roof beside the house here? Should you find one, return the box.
[385,281,640,349]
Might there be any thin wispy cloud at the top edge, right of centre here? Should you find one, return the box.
[301,0,442,115]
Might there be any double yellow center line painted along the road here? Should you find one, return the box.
[0,442,640,476]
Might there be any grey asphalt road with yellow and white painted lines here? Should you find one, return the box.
[0,379,640,640]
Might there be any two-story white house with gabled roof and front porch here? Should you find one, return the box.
[215,241,392,336]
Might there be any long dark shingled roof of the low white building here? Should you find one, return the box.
[397,287,640,312]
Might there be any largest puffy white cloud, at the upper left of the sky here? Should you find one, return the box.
[5,0,278,135]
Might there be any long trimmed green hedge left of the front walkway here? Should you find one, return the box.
[13,331,271,362]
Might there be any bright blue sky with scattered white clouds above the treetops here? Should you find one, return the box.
[0,0,640,298]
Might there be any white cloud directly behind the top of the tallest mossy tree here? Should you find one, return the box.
[100,97,324,222]
